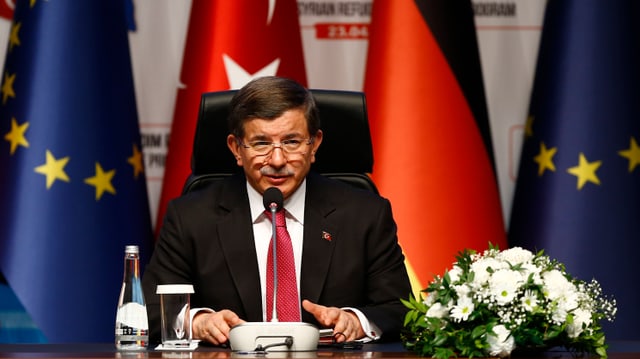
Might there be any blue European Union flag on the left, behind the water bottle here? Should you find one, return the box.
[0,0,152,343]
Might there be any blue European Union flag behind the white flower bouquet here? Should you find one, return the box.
[509,0,640,340]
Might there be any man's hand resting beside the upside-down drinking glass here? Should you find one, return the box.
[191,309,245,345]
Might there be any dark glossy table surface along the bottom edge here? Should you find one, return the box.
[0,342,640,359]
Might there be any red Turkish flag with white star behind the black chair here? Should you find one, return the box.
[156,0,307,233]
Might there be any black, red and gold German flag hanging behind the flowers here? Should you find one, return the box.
[365,0,507,292]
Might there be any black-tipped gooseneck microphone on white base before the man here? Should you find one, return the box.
[229,187,320,354]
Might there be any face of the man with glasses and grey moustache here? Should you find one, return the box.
[227,109,322,198]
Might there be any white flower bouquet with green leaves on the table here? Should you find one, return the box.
[401,245,617,358]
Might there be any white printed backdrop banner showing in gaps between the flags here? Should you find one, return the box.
[0,0,546,341]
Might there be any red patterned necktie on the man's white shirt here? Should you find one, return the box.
[265,210,300,322]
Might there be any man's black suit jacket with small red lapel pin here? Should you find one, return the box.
[143,173,411,342]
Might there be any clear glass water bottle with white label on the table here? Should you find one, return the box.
[115,246,149,350]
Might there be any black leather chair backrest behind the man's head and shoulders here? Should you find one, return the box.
[183,89,378,193]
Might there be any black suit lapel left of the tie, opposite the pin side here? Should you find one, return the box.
[217,176,262,321]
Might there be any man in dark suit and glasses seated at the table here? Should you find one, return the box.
[143,77,411,344]
